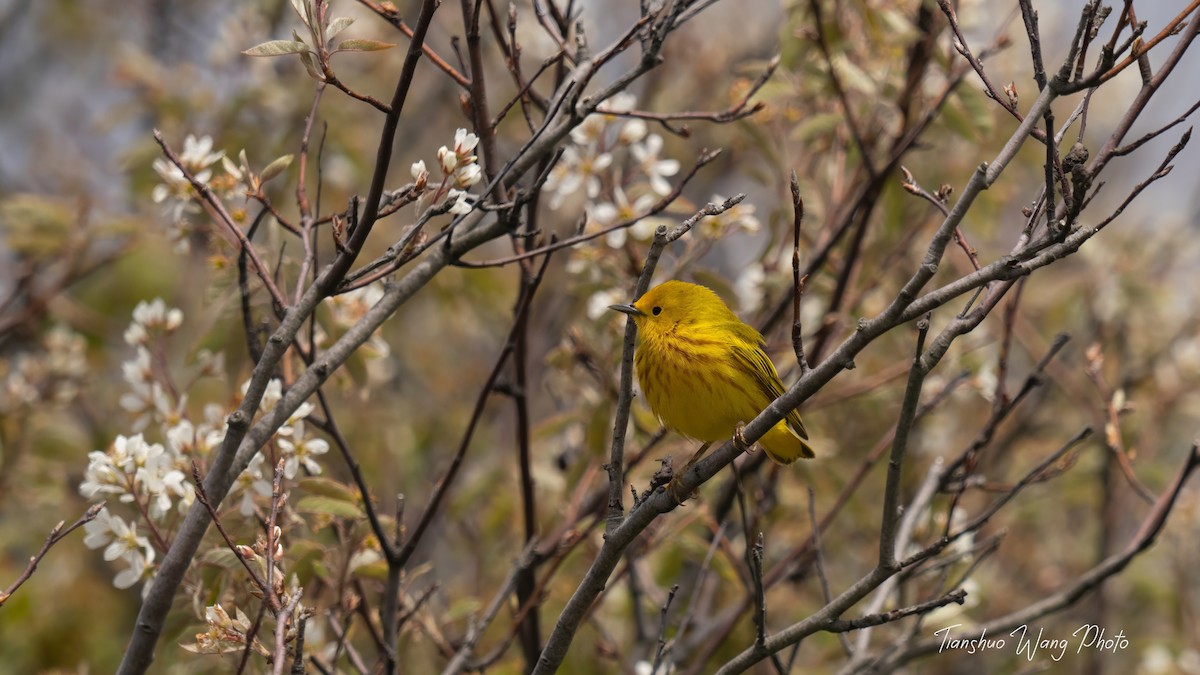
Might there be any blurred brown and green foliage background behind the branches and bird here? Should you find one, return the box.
[0,0,1200,674]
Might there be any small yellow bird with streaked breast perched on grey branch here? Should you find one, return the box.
[610,281,814,464]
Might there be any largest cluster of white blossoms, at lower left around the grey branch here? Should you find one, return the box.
[79,299,329,589]
